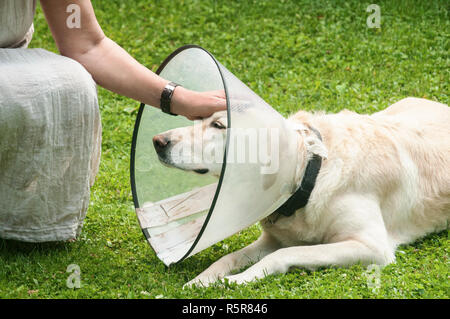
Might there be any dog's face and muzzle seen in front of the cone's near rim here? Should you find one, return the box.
[153,111,228,177]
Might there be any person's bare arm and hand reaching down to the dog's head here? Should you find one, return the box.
[40,0,226,119]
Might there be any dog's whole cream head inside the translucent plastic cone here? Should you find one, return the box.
[153,108,317,190]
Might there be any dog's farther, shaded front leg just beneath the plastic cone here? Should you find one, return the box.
[185,232,280,286]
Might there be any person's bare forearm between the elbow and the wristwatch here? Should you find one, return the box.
[67,37,169,107]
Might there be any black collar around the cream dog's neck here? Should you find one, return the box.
[275,127,322,216]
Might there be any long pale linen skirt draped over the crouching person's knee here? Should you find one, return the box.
[0,49,101,242]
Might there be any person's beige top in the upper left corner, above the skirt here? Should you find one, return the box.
[0,0,36,48]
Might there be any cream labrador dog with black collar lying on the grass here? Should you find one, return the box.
[153,98,450,286]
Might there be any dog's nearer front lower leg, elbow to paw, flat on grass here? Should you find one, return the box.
[225,240,387,284]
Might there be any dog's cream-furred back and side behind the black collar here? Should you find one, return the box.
[292,98,450,246]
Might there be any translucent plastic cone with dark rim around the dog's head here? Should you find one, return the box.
[131,46,297,265]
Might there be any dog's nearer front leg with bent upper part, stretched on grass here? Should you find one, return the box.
[226,194,395,284]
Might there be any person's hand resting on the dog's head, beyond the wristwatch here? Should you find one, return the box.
[171,86,227,120]
